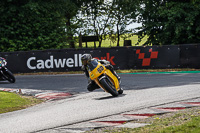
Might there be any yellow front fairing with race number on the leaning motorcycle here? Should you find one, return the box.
[89,63,120,91]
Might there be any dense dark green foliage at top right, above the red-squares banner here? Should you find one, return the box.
[139,0,200,45]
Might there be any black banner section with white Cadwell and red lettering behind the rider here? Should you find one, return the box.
[0,48,128,73]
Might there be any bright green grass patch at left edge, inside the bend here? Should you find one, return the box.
[0,91,42,114]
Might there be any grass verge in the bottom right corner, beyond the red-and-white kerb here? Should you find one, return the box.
[89,107,200,133]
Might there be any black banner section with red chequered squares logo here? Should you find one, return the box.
[126,46,180,69]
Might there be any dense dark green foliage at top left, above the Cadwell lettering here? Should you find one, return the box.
[0,0,66,51]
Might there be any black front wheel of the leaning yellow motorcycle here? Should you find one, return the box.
[100,78,118,97]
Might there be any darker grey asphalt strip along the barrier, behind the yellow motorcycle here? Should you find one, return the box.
[0,73,200,93]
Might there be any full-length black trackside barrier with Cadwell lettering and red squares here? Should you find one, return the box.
[0,44,200,73]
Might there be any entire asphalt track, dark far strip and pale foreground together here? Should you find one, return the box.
[0,73,200,133]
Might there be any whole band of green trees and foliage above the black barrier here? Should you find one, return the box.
[0,0,200,52]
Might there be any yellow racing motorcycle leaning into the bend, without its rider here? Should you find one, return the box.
[88,60,123,97]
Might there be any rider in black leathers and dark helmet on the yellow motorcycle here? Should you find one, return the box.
[81,54,120,91]
